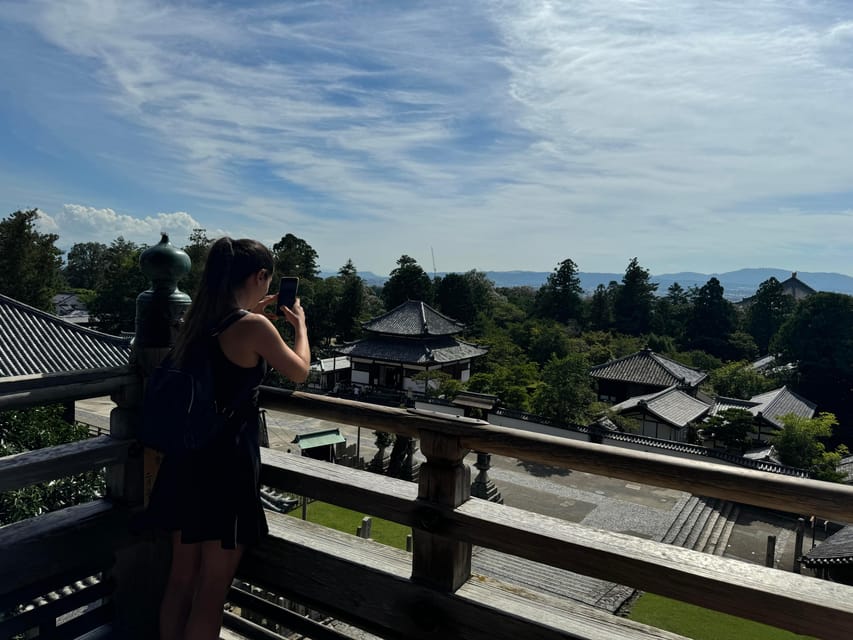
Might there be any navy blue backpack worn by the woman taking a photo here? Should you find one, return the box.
[139,309,248,455]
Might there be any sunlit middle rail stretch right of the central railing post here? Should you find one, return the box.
[456,500,853,640]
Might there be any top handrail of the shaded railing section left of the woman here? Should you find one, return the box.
[0,365,139,411]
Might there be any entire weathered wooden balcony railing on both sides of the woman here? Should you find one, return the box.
[0,377,853,640]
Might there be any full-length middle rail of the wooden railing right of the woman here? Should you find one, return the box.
[262,450,853,638]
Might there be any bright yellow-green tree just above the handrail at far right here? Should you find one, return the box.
[773,412,849,482]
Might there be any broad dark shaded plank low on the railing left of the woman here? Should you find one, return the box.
[0,500,129,596]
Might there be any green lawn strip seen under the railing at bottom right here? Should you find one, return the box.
[629,593,810,640]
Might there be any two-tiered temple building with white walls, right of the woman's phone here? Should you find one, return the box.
[336,300,487,393]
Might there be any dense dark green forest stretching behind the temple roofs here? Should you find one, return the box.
[0,210,853,480]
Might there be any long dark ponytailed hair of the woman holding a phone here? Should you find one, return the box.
[175,236,274,362]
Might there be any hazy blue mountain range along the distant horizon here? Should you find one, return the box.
[321,268,853,300]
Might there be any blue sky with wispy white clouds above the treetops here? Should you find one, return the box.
[0,0,853,275]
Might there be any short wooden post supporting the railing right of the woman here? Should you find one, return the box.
[412,431,471,591]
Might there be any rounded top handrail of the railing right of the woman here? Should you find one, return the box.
[255,388,853,522]
